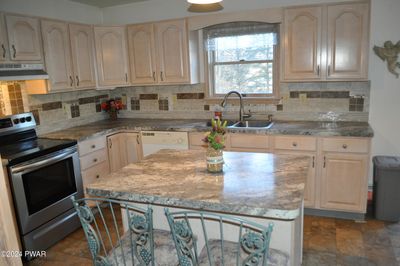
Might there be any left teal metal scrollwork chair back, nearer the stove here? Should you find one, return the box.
[71,197,155,265]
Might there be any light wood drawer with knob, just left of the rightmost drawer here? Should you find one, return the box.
[275,136,317,151]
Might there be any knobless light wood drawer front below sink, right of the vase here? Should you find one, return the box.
[230,134,269,149]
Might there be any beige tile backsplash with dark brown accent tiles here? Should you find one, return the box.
[0,82,370,133]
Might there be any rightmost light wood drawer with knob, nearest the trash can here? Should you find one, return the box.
[322,138,369,153]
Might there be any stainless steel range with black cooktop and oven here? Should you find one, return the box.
[0,113,83,259]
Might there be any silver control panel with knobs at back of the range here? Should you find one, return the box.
[0,113,36,135]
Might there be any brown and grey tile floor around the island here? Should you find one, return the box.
[25,216,400,266]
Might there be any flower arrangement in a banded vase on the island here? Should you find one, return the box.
[203,118,227,173]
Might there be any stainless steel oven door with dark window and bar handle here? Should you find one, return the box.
[9,146,83,235]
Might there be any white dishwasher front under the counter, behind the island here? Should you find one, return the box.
[141,131,189,156]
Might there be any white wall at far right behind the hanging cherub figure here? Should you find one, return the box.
[369,0,400,156]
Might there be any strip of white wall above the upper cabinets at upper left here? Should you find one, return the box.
[0,0,102,24]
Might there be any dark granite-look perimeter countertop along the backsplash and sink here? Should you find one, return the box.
[41,118,373,141]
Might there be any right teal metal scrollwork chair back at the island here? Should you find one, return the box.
[165,209,273,266]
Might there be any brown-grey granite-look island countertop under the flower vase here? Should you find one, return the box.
[87,150,310,220]
